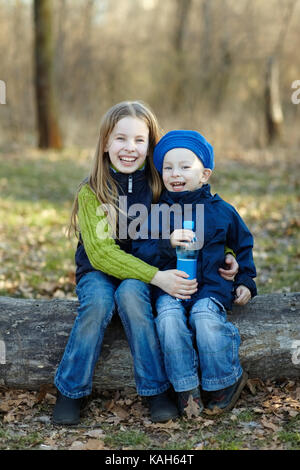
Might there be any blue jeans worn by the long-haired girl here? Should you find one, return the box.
[54,271,170,398]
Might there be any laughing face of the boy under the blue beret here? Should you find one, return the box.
[162,148,211,192]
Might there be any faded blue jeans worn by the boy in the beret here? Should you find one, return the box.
[156,294,243,392]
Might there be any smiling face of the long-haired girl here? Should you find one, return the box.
[105,116,149,174]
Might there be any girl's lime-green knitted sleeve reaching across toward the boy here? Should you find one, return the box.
[78,185,158,283]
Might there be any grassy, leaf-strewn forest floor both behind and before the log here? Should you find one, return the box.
[0,147,300,450]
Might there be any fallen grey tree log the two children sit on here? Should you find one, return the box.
[0,293,300,390]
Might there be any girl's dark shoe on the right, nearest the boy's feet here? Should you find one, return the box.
[147,391,179,423]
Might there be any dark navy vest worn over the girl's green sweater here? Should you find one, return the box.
[75,167,152,284]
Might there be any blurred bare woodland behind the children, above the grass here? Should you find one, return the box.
[0,0,300,149]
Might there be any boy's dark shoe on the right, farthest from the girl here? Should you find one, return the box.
[206,372,248,414]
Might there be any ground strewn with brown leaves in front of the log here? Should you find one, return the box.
[0,378,300,450]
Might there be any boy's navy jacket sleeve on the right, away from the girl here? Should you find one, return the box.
[227,206,257,297]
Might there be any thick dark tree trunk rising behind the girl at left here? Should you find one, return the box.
[34,0,62,149]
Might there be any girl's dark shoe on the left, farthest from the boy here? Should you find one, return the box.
[52,391,84,425]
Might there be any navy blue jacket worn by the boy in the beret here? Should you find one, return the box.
[132,184,257,310]
